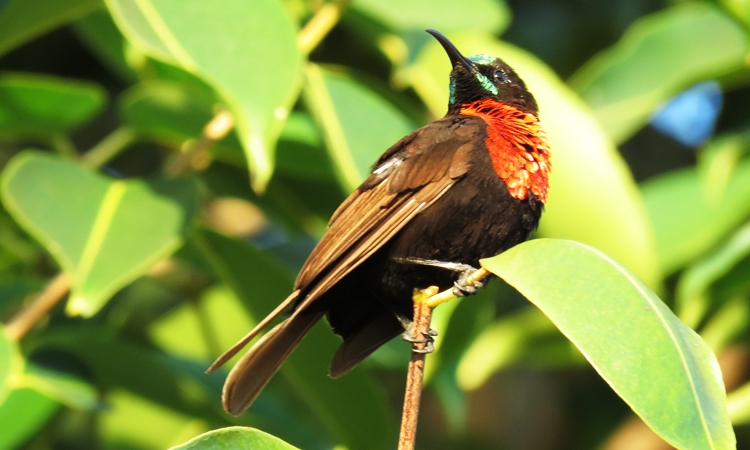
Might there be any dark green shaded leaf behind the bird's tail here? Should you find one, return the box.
[194,231,396,449]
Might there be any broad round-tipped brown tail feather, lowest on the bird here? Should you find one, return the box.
[222,313,323,416]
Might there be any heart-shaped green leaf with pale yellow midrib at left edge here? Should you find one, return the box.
[2,151,200,316]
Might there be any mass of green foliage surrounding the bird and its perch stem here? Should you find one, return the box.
[0,0,750,450]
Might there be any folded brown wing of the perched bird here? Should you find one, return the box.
[295,117,484,315]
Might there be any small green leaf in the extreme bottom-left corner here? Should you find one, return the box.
[0,389,60,449]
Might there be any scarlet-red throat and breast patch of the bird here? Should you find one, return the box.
[460,99,550,203]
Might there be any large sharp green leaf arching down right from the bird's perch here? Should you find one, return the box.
[482,239,736,450]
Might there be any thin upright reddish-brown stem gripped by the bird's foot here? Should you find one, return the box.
[398,286,438,450]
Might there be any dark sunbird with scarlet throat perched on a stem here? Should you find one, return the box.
[208,30,550,415]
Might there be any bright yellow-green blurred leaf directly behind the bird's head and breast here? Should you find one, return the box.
[409,35,661,286]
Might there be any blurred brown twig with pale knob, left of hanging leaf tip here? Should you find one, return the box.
[164,110,234,177]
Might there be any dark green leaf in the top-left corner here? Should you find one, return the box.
[0,0,102,56]
